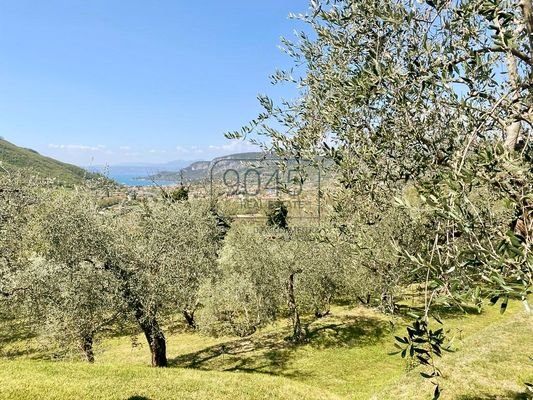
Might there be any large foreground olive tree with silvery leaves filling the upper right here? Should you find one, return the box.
[227,0,533,397]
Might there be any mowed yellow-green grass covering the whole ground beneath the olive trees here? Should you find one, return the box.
[0,303,533,400]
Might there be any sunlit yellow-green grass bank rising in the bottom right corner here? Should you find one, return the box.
[374,303,533,400]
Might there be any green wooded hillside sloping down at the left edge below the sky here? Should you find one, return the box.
[0,138,95,185]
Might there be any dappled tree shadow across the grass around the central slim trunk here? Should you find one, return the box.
[170,316,388,378]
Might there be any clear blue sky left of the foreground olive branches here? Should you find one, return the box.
[0,0,308,165]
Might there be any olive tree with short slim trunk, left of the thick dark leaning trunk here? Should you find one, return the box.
[24,189,124,362]
